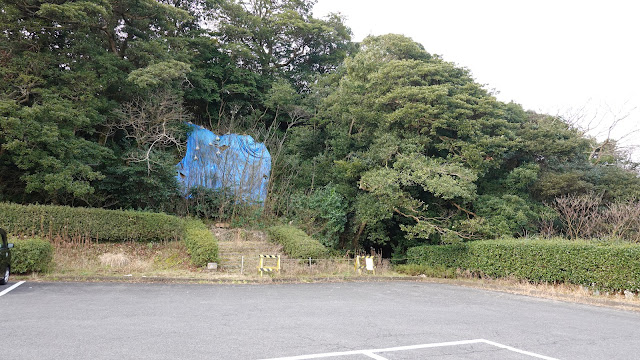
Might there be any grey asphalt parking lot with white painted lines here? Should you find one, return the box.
[0,282,640,360]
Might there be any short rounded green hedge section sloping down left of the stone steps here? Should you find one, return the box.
[184,219,218,266]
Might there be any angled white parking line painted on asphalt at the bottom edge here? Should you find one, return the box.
[262,339,558,360]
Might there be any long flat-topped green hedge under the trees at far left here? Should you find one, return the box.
[0,203,184,241]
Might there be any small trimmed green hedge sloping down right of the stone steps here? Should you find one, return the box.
[267,225,329,259]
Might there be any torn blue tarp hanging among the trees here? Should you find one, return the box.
[177,124,271,203]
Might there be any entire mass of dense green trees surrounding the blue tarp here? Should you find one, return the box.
[0,0,640,253]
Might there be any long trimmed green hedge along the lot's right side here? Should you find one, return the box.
[407,239,640,291]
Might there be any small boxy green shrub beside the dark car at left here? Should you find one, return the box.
[11,238,53,274]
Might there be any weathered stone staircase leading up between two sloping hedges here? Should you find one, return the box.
[211,227,284,274]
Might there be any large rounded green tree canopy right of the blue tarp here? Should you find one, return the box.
[278,35,638,250]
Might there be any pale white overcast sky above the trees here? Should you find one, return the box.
[314,0,640,160]
